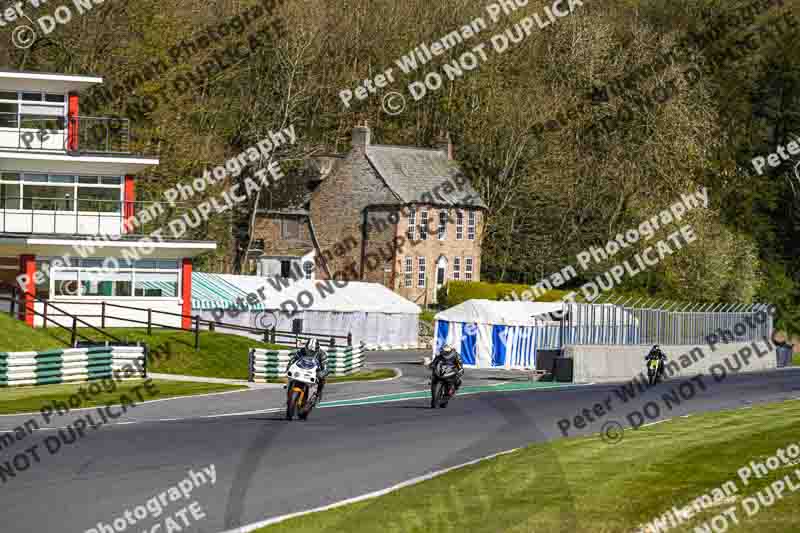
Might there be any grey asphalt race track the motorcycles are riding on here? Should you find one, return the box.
[0,352,800,533]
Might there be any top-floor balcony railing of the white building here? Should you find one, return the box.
[0,113,131,155]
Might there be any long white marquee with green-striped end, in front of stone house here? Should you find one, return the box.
[192,273,421,348]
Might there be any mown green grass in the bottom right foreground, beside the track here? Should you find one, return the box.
[259,401,800,533]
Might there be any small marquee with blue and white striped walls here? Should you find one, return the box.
[433,300,563,369]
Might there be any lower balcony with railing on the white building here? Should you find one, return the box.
[0,196,189,236]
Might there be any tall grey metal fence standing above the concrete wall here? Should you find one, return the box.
[540,298,773,349]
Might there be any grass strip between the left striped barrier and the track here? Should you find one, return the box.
[0,379,247,415]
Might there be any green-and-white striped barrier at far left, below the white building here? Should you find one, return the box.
[0,346,146,387]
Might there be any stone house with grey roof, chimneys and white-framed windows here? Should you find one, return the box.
[254,126,486,305]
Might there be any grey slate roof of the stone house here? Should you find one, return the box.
[366,144,486,208]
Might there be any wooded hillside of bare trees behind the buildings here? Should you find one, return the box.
[0,0,800,329]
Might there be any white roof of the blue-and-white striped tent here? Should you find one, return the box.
[434,300,563,326]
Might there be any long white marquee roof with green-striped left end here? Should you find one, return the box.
[192,272,421,315]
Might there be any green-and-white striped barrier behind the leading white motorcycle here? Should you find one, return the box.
[250,343,366,382]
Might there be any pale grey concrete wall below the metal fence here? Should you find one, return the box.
[564,339,777,383]
